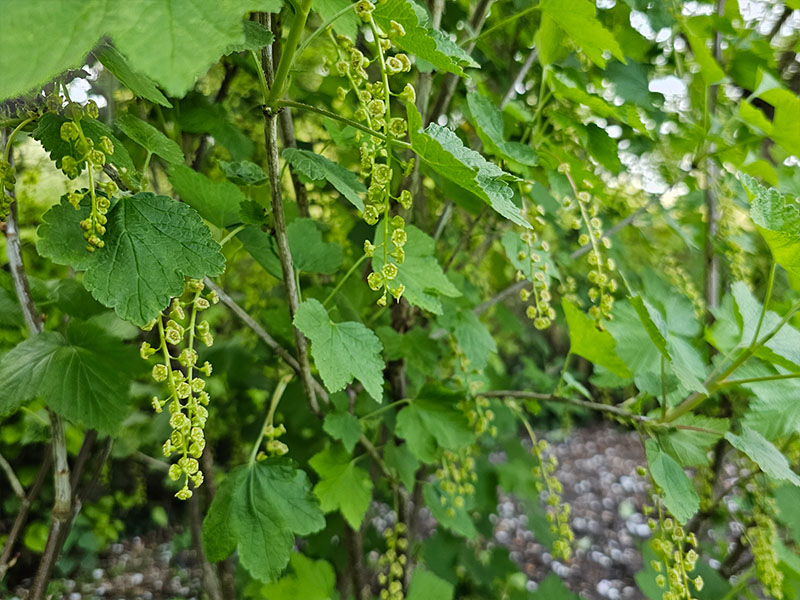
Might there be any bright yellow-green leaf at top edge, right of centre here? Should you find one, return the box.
[539,0,625,68]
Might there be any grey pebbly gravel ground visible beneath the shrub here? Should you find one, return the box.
[12,424,650,600]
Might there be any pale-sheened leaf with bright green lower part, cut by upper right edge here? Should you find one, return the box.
[740,174,800,290]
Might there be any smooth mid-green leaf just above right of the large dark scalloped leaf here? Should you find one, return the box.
[167,165,245,228]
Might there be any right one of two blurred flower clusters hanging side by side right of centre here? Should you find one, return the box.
[558,163,617,325]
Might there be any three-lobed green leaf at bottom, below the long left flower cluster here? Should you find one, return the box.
[203,458,325,583]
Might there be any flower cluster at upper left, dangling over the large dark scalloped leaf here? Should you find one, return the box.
[59,100,117,252]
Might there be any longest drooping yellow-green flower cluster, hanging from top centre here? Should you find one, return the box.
[331,0,415,306]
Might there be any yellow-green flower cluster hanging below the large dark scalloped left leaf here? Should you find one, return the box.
[140,279,218,500]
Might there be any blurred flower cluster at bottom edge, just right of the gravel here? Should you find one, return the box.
[648,509,703,600]
